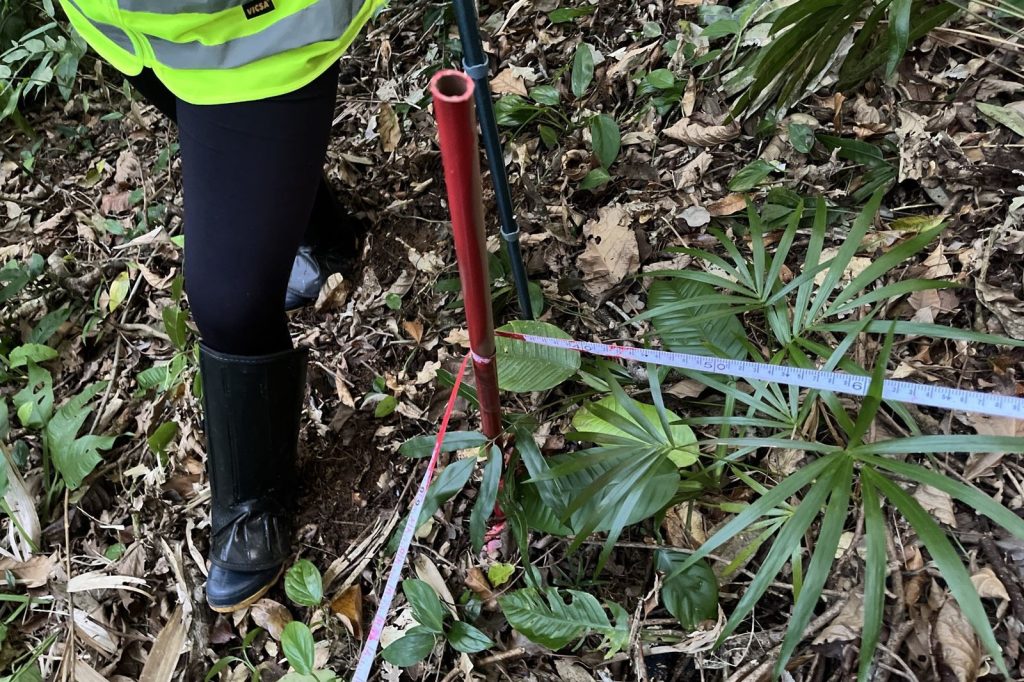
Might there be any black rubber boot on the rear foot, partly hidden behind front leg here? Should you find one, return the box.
[285,176,367,310]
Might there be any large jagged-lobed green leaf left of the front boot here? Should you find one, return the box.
[43,382,114,489]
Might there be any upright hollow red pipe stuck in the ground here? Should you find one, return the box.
[430,71,502,438]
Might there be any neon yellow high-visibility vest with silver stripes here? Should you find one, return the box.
[60,0,387,104]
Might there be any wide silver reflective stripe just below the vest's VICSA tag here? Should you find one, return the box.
[147,0,364,69]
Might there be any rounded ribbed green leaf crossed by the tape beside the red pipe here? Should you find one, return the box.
[496,321,580,393]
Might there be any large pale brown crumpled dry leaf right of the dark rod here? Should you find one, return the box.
[578,204,640,296]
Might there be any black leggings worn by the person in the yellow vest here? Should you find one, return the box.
[129,65,338,355]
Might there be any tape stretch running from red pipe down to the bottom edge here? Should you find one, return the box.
[352,353,470,682]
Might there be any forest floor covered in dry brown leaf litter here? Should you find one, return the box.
[0,0,1024,682]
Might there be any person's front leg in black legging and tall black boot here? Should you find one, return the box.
[176,61,337,611]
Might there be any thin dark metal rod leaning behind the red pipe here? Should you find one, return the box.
[454,0,534,319]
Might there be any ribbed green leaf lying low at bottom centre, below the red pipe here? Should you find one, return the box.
[498,588,629,655]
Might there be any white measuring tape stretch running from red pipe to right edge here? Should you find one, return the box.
[497,332,1024,419]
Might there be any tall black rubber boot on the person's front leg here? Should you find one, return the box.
[200,346,306,612]
